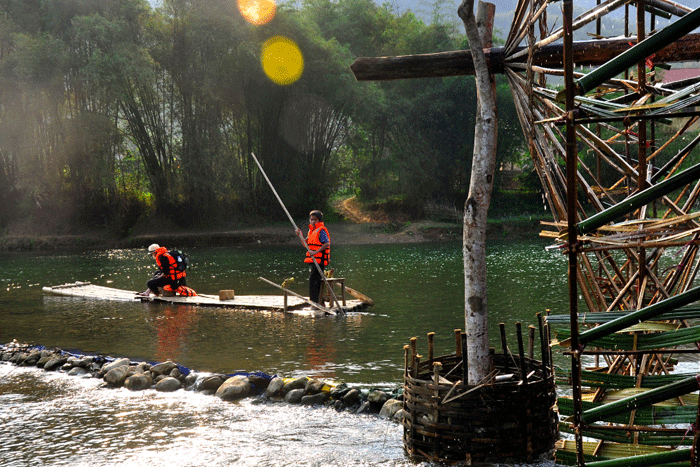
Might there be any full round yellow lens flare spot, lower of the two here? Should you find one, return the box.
[260,36,304,85]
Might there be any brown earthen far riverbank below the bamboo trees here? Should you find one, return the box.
[0,218,542,251]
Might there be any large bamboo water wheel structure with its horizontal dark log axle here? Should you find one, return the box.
[351,0,700,466]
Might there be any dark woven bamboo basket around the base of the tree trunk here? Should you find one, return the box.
[404,353,559,465]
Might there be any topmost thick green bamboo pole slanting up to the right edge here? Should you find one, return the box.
[574,8,700,94]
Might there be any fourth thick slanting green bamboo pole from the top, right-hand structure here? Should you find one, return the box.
[581,376,698,423]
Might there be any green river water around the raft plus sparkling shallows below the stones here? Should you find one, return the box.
[0,240,568,466]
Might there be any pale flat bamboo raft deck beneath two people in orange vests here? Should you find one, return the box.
[42,282,367,316]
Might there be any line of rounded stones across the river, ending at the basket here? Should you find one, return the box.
[0,342,404,421]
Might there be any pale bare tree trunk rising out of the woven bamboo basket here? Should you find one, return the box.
[458,0,498,384]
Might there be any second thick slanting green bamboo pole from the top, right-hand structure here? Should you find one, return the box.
[577,164,700,235]
